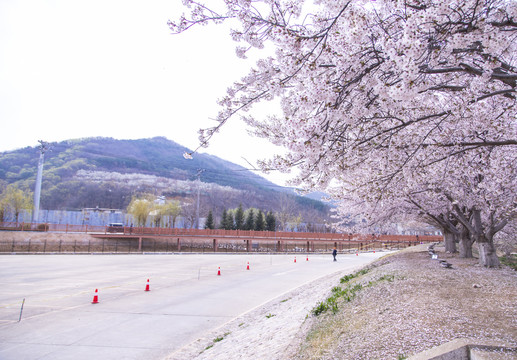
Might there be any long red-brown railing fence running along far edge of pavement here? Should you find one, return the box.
[0,222,443,253]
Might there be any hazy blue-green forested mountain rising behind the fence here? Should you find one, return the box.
[0,137,328,224]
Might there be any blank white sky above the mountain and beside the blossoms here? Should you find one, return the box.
[0,0,286,185]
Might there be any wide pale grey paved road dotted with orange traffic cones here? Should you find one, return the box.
[0,253,385,360]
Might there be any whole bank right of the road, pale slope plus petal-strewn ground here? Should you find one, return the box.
[167,246,517,360]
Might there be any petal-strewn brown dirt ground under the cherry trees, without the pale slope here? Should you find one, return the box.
[286,246,517,359]
